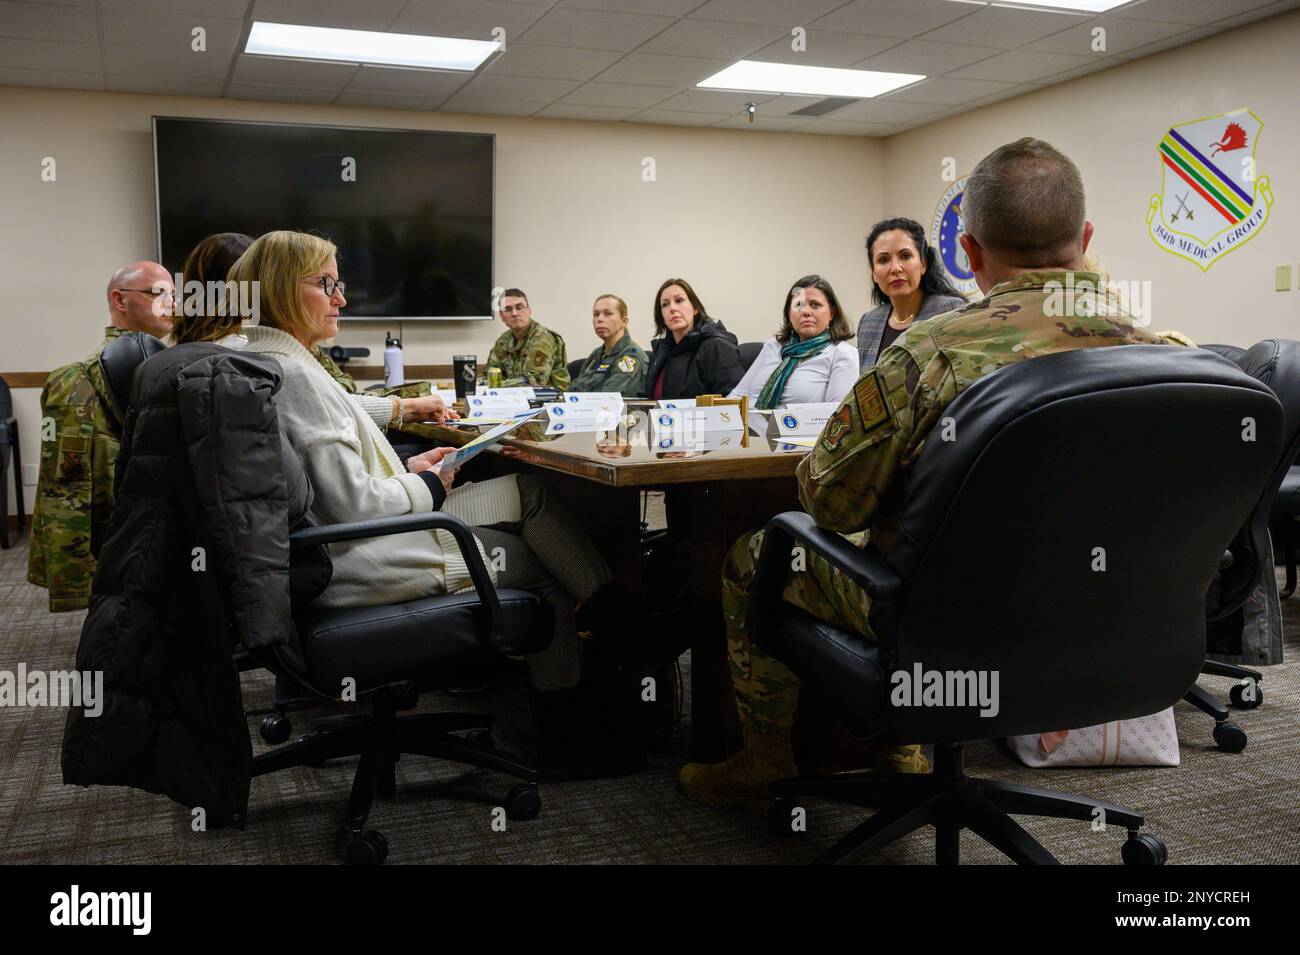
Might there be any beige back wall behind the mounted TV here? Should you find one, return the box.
[0,87,883,511]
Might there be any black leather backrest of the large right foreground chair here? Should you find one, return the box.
[871,346,1283,741]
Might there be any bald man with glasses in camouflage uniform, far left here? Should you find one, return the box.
[27,261,176,611]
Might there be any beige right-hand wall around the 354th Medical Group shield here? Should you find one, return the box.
[884,13,1300,344]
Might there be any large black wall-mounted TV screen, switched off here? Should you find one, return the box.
[153,116,495,321]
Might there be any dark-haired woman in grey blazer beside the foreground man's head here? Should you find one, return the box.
[858,218,966,368]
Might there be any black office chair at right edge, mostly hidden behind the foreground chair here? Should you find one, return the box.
[1186,339,1300,752]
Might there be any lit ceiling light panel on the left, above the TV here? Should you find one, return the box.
[244,21,499,70]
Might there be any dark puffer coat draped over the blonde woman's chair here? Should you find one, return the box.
[62,344,311,825]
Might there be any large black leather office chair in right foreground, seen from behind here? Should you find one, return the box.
[749,346,1282,864]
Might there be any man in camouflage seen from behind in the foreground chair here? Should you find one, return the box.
[677,138,1165,811]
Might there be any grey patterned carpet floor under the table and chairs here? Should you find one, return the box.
[0,522,1300,864]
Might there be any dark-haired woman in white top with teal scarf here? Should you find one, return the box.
[729,275,858,411]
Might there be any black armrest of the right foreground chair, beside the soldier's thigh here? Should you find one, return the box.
[749,511,902,646]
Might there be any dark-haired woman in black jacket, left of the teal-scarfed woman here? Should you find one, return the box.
[646,278,745,400]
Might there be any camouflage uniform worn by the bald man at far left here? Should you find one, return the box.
[27,326,126,612]
